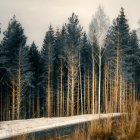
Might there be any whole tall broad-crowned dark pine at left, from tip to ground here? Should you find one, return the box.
[1,16,26,119]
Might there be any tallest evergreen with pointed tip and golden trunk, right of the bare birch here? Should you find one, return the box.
[106,8,136,111]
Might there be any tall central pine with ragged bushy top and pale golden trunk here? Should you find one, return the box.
[65,13,82,115]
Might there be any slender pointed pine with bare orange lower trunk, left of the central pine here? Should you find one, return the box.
[41,25,55,117]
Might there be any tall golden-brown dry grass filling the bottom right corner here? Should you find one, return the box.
[67,100,140,140]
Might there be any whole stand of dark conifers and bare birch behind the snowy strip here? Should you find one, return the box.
[0,7,140,121]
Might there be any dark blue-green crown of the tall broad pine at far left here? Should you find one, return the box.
[1,16,26,75]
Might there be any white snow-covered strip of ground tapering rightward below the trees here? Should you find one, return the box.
[0,113,121,139]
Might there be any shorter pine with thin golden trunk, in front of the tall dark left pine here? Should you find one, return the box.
[13,46,32,119]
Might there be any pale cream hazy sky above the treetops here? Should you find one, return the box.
[0,0,140,48]
